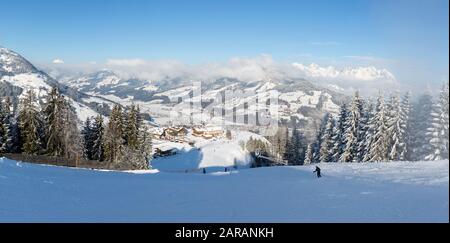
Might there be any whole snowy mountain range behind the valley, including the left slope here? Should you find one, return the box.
[0,48,348,138]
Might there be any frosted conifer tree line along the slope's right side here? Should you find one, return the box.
[247,84,449,165]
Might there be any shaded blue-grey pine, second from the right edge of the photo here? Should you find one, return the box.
[409,94,433,161]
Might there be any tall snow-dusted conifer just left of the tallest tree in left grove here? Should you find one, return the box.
[19,90,42,155]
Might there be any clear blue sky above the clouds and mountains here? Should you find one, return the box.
[0,0,449,87]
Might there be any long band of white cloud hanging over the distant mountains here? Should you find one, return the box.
[42,54,399,96]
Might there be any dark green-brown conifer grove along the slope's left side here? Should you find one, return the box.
[0,88,152,169]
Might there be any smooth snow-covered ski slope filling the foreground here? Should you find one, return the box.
[0,159,449,222]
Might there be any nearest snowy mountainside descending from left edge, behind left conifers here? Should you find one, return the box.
[0,47,113,121]
